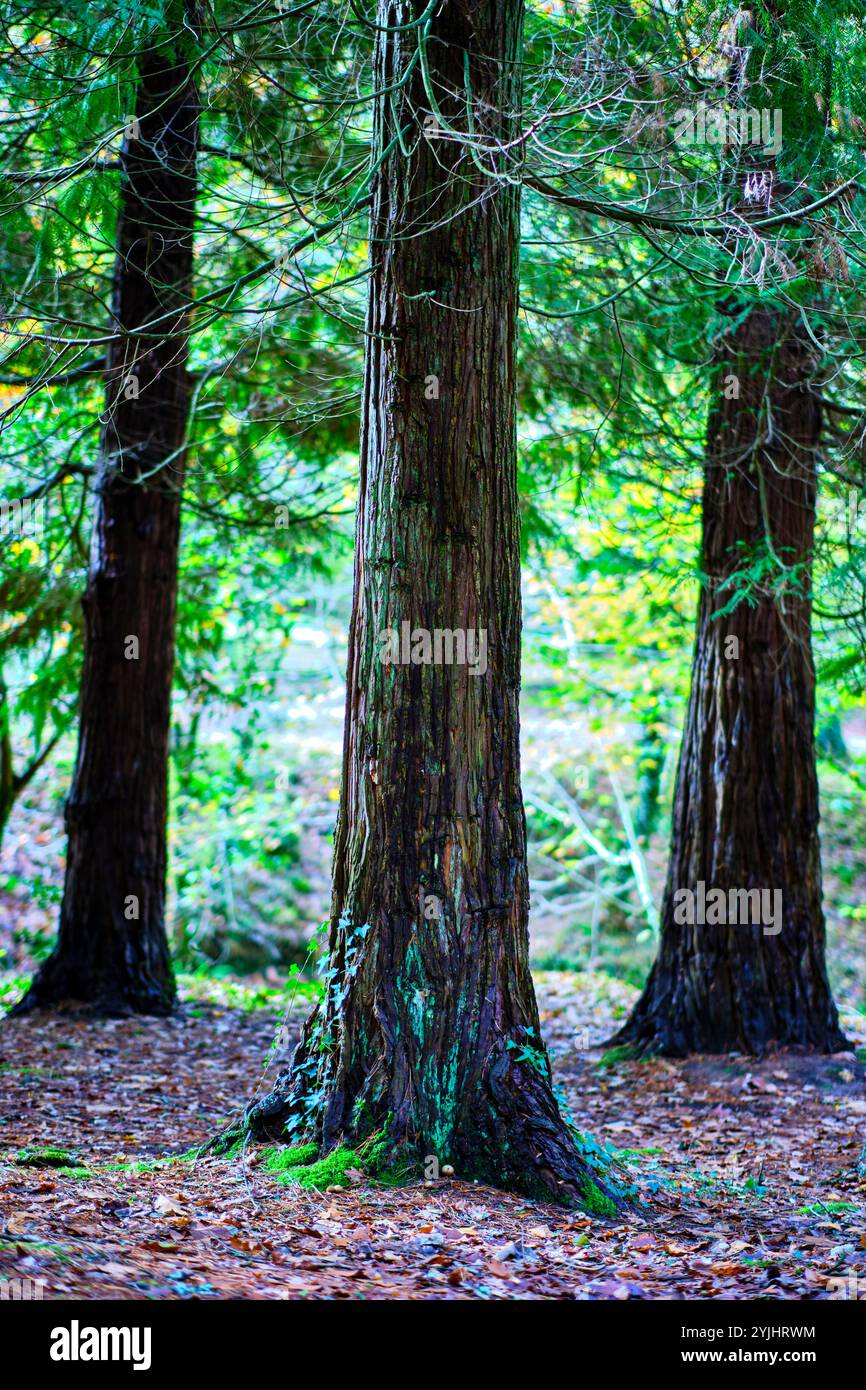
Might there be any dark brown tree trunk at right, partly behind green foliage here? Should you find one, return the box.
[619,307,845,1056]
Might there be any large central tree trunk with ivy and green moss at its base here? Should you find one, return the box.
[249,0,619,1204]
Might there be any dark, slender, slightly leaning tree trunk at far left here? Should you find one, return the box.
[17,26,199,1013]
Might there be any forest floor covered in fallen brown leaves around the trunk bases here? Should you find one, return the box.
[0,972,866,1300]
